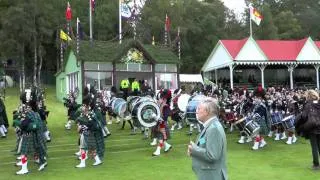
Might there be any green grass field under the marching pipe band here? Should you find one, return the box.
[0,87,320,180]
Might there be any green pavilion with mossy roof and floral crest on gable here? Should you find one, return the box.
[56,40,179,103]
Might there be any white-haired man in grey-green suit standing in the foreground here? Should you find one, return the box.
[188,98,228,180]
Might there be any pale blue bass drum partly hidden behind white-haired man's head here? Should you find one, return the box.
[185,95,206,123]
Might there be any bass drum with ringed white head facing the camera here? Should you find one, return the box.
[131,100,160,128]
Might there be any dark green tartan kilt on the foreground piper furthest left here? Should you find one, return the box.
[18,133,35,155]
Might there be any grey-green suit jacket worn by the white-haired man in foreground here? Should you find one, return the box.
[191,117,228,180]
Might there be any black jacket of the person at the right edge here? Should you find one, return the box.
[295,101,320,138]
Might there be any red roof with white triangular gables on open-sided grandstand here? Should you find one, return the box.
[202,37,320,72]
